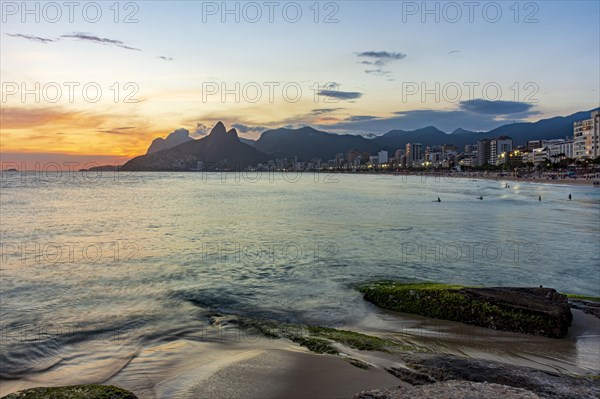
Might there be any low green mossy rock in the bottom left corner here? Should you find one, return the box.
[2,385,138,399]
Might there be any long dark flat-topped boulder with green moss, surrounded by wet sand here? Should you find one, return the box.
[359,281,573,338]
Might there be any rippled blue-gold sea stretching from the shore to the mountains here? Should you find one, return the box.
[0,172,600,390]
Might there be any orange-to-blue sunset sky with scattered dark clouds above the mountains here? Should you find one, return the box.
[0,1,600,164]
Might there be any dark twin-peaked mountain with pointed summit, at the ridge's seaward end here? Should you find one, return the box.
[121,122,270,171]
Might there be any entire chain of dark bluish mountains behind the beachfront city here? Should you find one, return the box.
[123,110,593,170]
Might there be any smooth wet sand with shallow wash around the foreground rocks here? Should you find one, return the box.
[0,308,600,399]
